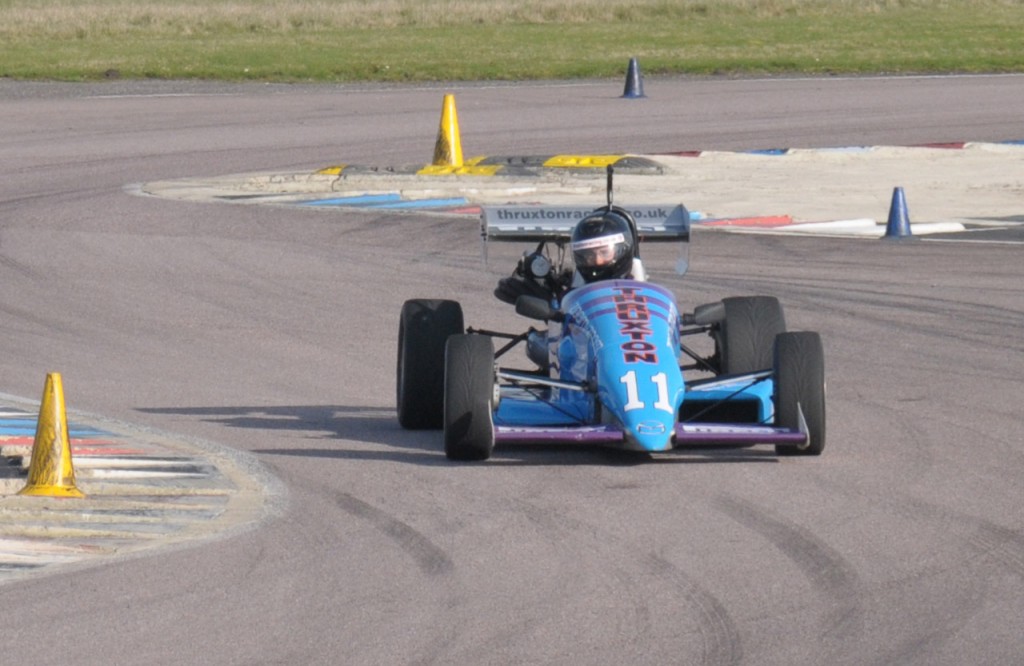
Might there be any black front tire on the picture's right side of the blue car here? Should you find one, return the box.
[774,331,825,456]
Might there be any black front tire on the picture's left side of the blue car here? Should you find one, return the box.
[444,335,496,460]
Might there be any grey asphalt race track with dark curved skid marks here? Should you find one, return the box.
[0,77,1024,664]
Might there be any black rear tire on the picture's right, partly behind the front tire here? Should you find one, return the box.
[717,296,785,375]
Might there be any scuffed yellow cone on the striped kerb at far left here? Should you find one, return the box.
[18,372,85,497]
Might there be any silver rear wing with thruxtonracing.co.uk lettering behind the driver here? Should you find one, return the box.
[480,204,690,275]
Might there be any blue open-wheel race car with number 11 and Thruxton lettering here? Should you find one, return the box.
[396,170,825,460]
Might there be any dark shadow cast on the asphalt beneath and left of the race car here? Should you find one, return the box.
[136,405,777,466]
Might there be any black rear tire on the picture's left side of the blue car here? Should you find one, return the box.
[395,298,465,430]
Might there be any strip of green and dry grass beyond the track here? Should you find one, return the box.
[0,0,1024,82]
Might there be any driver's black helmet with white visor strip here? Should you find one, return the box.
[570,209,636,282]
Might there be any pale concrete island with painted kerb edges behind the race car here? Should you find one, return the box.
[135,142,1024,238]
